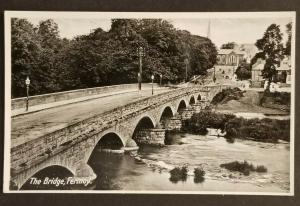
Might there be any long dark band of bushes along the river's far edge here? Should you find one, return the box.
[183,111,290,142]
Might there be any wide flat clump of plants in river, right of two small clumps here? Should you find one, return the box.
[220,161,268,176]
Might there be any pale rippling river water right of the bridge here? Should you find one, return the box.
[89,133,290,192]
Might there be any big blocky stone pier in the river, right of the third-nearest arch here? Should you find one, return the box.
[135,128,166,146]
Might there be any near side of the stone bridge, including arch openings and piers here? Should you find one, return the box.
[10,86,230,189]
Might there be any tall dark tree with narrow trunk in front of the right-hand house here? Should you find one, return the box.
[255,24,283,90]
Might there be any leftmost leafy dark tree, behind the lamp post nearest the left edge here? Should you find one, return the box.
[11,18,41,98]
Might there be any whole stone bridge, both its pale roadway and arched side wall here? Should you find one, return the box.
[5,83,227,189]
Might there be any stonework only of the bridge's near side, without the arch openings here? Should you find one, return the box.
[10,86,230,188]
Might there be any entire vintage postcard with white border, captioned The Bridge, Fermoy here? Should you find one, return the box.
[3,11,296,196]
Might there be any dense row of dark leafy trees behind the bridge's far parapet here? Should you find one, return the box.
[11,18,217,98]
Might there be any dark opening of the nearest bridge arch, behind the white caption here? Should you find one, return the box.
[19,164,74,190]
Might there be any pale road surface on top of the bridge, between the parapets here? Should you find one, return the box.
[11,87,171,147]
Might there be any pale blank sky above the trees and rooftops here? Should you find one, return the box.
[28,17,292,47]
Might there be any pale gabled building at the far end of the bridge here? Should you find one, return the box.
[215,49,245,79]
